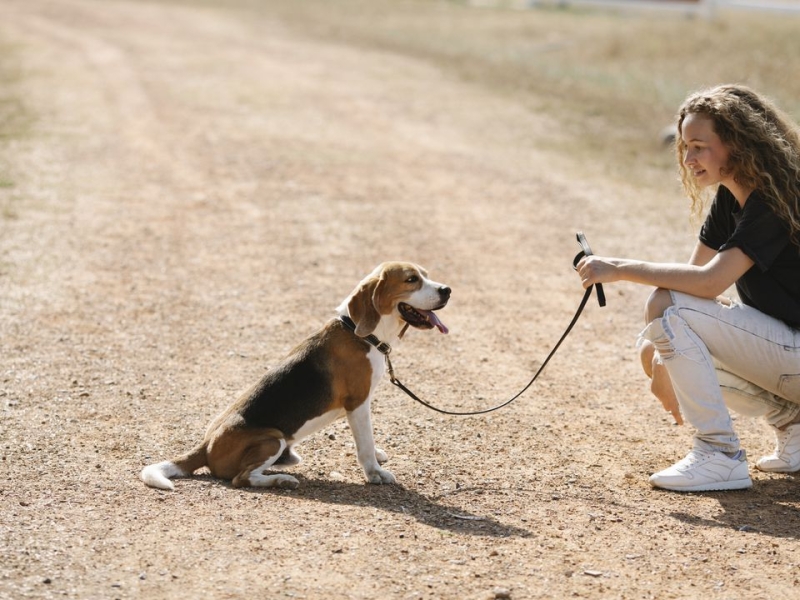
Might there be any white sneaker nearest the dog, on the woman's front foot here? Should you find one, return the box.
[650,448,753,492]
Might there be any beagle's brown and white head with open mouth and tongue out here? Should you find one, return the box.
[343,262,450,337]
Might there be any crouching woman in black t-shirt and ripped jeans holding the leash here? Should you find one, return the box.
[578,85,800,492]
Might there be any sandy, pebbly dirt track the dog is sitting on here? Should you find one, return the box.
[0,0,800,600]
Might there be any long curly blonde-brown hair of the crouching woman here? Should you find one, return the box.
[675,84,800,246]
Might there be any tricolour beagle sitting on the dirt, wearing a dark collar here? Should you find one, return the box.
[141,262,450,490]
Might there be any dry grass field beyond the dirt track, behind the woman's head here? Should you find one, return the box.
[183,0,800,182]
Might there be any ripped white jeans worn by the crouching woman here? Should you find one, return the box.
[640,292,800,452]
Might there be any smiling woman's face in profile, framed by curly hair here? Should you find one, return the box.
[681,113,732,187]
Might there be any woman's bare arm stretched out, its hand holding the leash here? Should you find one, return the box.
[577,242,754,298]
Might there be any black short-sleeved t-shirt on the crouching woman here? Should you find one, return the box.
[700,185,800,329]
